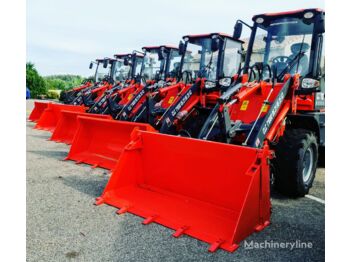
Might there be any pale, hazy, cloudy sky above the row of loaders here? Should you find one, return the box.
[27,0,324,76]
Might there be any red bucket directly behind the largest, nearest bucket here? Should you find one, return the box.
[66,116,154,169]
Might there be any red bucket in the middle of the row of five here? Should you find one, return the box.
[50,110,112,145]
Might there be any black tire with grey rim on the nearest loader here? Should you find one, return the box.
[272,128,318,197]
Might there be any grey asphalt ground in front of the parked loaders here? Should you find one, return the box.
[26,100,325,261]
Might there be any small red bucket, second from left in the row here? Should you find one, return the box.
[34,104,86,132]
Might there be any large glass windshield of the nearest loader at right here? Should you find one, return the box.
[250,18,313,79]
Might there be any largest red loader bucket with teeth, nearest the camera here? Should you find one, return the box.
[96,131,270,252]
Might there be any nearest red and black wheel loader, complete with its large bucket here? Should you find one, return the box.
[96,9,325,252]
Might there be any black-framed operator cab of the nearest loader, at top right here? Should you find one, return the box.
[241,9,325,82]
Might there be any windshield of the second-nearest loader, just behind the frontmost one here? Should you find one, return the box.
[183,38,219,80]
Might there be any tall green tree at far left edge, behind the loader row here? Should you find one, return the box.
[26,62,47,98]
